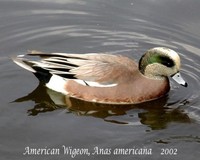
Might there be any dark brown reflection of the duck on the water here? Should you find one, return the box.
[14,84,190,129]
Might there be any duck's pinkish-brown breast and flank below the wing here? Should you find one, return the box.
[61,65,170,104]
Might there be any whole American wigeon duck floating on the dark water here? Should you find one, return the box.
[13,47,187,104]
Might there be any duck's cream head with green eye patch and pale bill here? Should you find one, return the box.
[139,47,187,87]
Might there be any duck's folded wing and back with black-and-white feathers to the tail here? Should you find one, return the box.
[14,51,137,84]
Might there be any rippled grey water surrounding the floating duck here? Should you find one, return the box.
[0,0,200,160]
